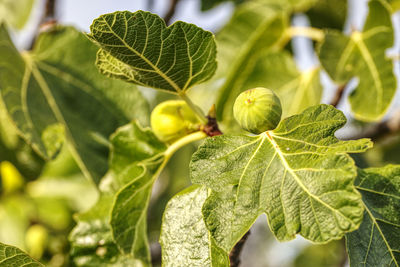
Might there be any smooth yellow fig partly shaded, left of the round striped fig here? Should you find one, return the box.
[150,100,201,143]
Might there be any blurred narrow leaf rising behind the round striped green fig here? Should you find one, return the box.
[216,1,288,120]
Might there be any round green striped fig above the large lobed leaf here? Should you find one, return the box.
[233,87,282,134]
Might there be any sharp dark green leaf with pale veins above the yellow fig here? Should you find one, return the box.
[88,11,217,94]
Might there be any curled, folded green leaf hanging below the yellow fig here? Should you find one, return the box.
[70,123,166,266]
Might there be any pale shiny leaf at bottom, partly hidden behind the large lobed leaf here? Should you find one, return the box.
[160,186,229,267]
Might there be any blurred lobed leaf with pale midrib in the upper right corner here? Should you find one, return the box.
[319,0,397,121]
